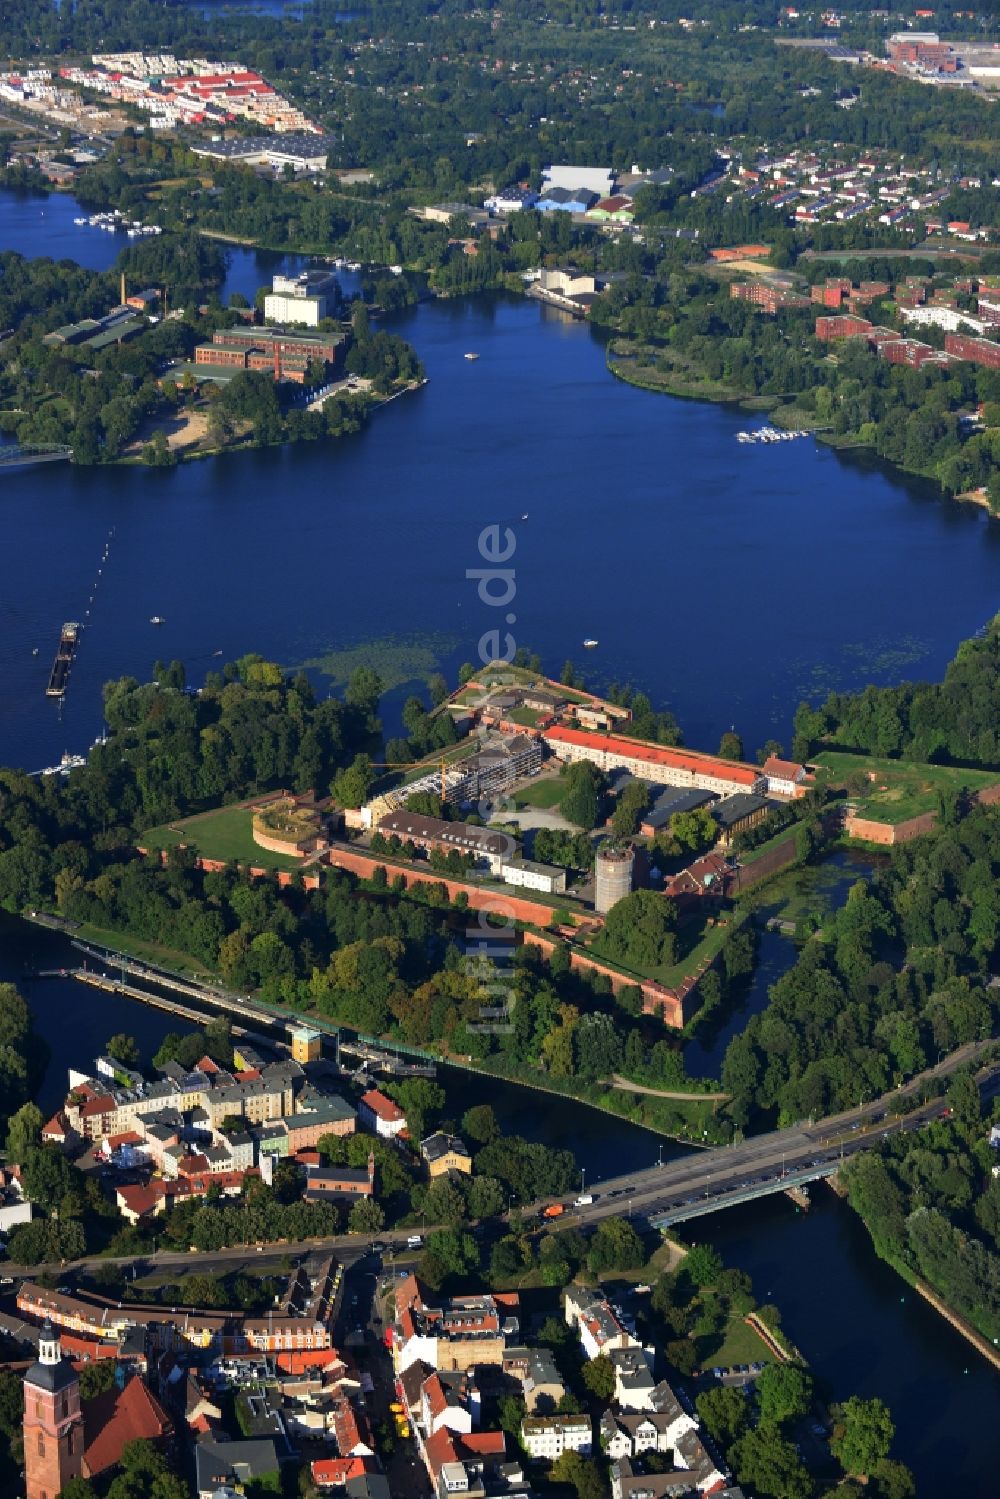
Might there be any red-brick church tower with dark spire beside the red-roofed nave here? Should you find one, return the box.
[24,1318,84,1499]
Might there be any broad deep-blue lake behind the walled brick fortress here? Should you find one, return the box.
[0,195,1000,767]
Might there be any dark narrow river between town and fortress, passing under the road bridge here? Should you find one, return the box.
[0,913,1000,1499]
